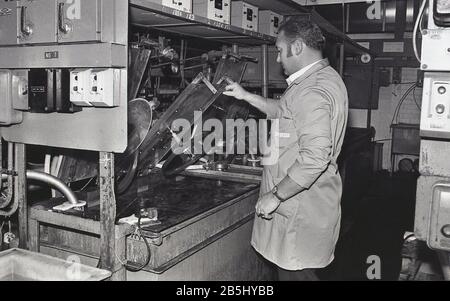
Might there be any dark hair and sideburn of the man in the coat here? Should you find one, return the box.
[279,16,325,51]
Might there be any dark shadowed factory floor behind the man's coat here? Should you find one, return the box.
[321,172,424,281]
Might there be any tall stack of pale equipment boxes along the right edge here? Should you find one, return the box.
[415,0,450,279]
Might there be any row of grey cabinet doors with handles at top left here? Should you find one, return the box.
[0,0,127,45]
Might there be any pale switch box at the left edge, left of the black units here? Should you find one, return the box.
[0,70,23,126]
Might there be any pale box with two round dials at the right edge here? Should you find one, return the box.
[420,72,450,139]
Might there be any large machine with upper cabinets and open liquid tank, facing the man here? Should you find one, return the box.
[0,0,274,280]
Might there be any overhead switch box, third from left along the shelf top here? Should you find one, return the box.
[231,1,259,31]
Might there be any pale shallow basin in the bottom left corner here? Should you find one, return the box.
[0,249,111,281]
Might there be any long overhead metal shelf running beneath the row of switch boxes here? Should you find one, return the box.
[130,0,276,46]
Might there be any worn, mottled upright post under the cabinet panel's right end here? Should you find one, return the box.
[99,152,126,280]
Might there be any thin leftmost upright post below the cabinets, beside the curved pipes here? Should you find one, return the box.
[14,143,28,249]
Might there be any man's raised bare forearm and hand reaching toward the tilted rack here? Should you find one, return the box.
[223,83,282,119]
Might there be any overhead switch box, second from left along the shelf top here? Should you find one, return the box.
[194,0,231,24]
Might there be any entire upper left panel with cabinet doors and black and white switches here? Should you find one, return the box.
[0,0,129,153]
